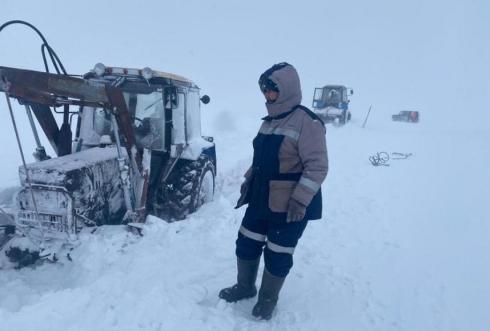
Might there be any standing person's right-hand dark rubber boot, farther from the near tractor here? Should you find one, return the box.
[252,268,286,320]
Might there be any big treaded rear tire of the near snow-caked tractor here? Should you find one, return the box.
[152,155,216,222]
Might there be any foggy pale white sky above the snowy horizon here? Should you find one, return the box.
[0,0,490,128]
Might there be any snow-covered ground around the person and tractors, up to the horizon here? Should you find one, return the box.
[0,113,490,331]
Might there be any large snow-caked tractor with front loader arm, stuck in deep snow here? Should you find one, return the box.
[0,63,216,264]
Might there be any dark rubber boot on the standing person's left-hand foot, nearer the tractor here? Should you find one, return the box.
[219,258,260,302]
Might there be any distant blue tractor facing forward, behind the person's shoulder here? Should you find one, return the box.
[312,85,354,125]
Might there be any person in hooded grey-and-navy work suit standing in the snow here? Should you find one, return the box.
[219,62,328,320]
